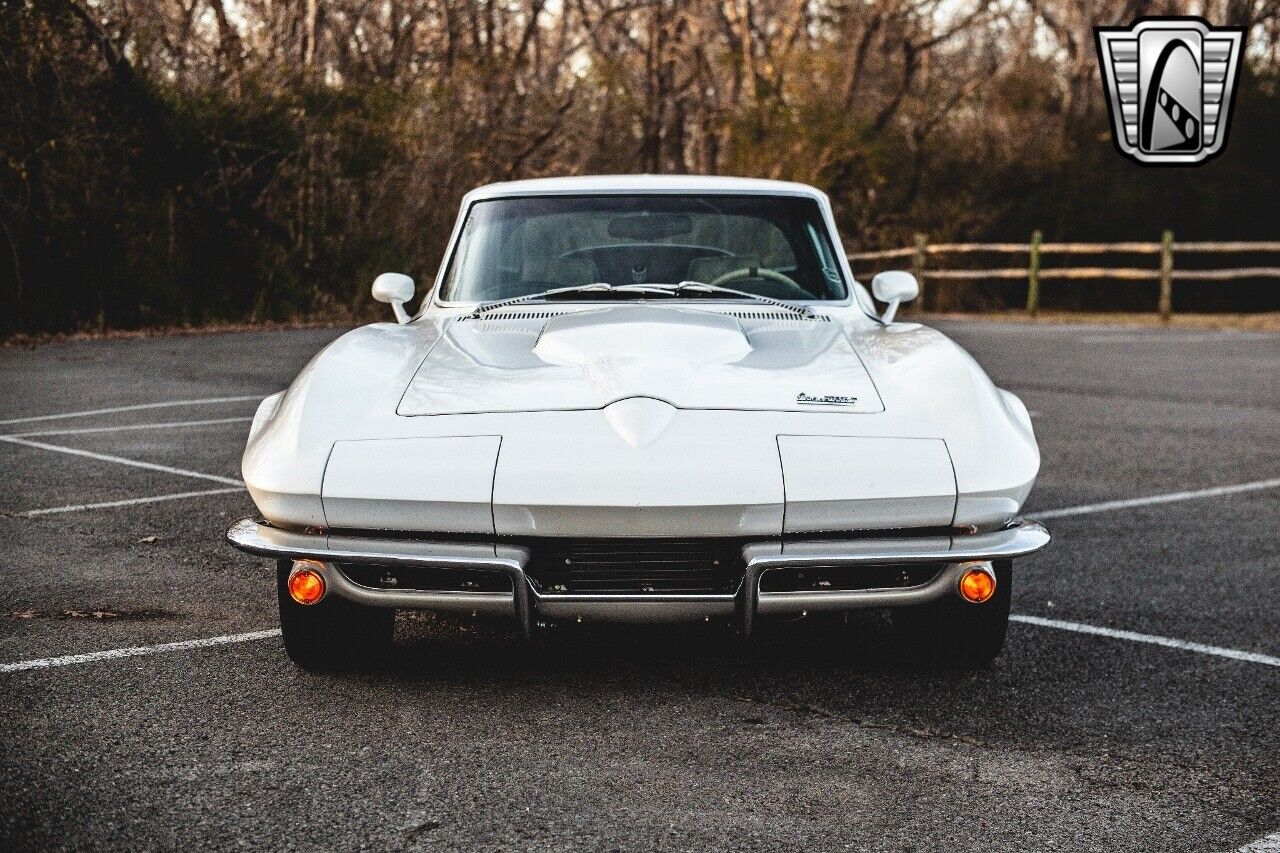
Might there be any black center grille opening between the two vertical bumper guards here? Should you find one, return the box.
[526,539,745,596]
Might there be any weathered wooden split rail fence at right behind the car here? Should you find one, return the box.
[849,231,1280,320]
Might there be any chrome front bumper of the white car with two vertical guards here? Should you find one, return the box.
[227,519,1050,637]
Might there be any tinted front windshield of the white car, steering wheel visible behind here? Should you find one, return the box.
[440,195,847,302]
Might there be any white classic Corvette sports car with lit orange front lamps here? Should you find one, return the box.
[227,177,1048,669]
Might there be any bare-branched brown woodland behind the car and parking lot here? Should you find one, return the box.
[0,0,1280,337]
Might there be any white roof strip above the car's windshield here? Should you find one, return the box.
[463,174,827,205]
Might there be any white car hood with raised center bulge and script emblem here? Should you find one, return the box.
[397,305,883,416]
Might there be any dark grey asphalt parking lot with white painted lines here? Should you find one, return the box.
[0,323,1280,852]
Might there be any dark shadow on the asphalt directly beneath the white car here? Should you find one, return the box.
[370,612,1002,699]
